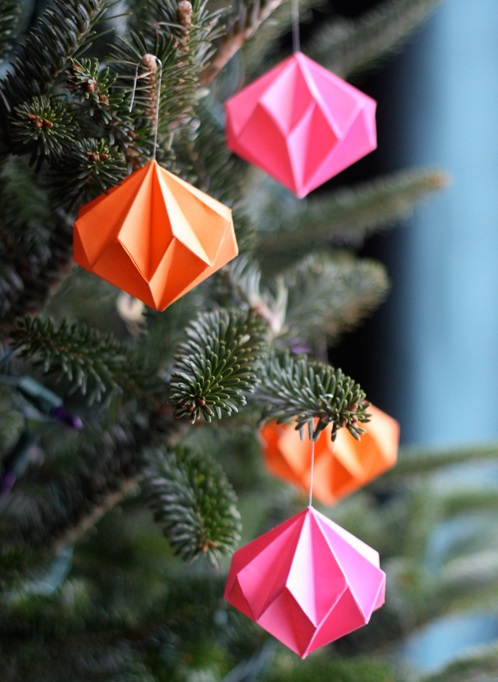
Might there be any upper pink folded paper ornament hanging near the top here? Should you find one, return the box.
[226,52,377,198]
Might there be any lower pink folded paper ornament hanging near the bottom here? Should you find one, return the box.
[225,506,386,658]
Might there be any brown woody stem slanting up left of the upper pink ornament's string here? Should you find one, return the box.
[199,0,282,85]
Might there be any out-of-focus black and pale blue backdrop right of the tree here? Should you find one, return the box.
[334,0,498,446]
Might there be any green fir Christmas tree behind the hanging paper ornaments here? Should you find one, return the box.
[0,0,498,682]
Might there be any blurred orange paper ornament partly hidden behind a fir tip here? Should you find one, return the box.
[260,405,399,504]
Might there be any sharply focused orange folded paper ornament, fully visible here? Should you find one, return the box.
[73,161,238,310]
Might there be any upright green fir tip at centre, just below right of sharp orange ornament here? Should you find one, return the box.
[170,309,267,422]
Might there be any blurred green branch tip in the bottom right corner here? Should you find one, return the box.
[420,644,498,682]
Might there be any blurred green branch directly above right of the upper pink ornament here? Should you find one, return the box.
[309,0,441,78]
